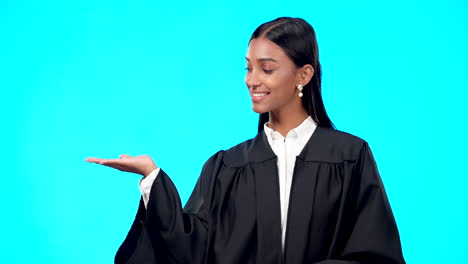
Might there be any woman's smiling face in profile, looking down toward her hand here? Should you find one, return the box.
[245,38,302,113]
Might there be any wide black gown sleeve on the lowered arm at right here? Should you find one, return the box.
[316,143,405,264]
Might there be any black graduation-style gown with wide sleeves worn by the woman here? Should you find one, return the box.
[115,127,405,264]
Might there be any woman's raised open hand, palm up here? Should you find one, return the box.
[85,154,158,176]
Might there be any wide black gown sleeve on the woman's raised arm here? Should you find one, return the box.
[115,152,223,264]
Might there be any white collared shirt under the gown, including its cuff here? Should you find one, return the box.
[140,116,317,248]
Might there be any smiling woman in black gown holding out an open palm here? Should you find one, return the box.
[87,17,405,264]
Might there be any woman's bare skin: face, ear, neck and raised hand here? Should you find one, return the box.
[85,37,314,176]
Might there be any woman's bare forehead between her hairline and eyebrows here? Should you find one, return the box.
[246,38,289,61]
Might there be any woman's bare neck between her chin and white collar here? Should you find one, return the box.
[268,107,309,137]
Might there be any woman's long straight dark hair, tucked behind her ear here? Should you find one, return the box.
[249,17,335,132]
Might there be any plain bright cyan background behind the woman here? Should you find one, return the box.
[0,0,468,264]
